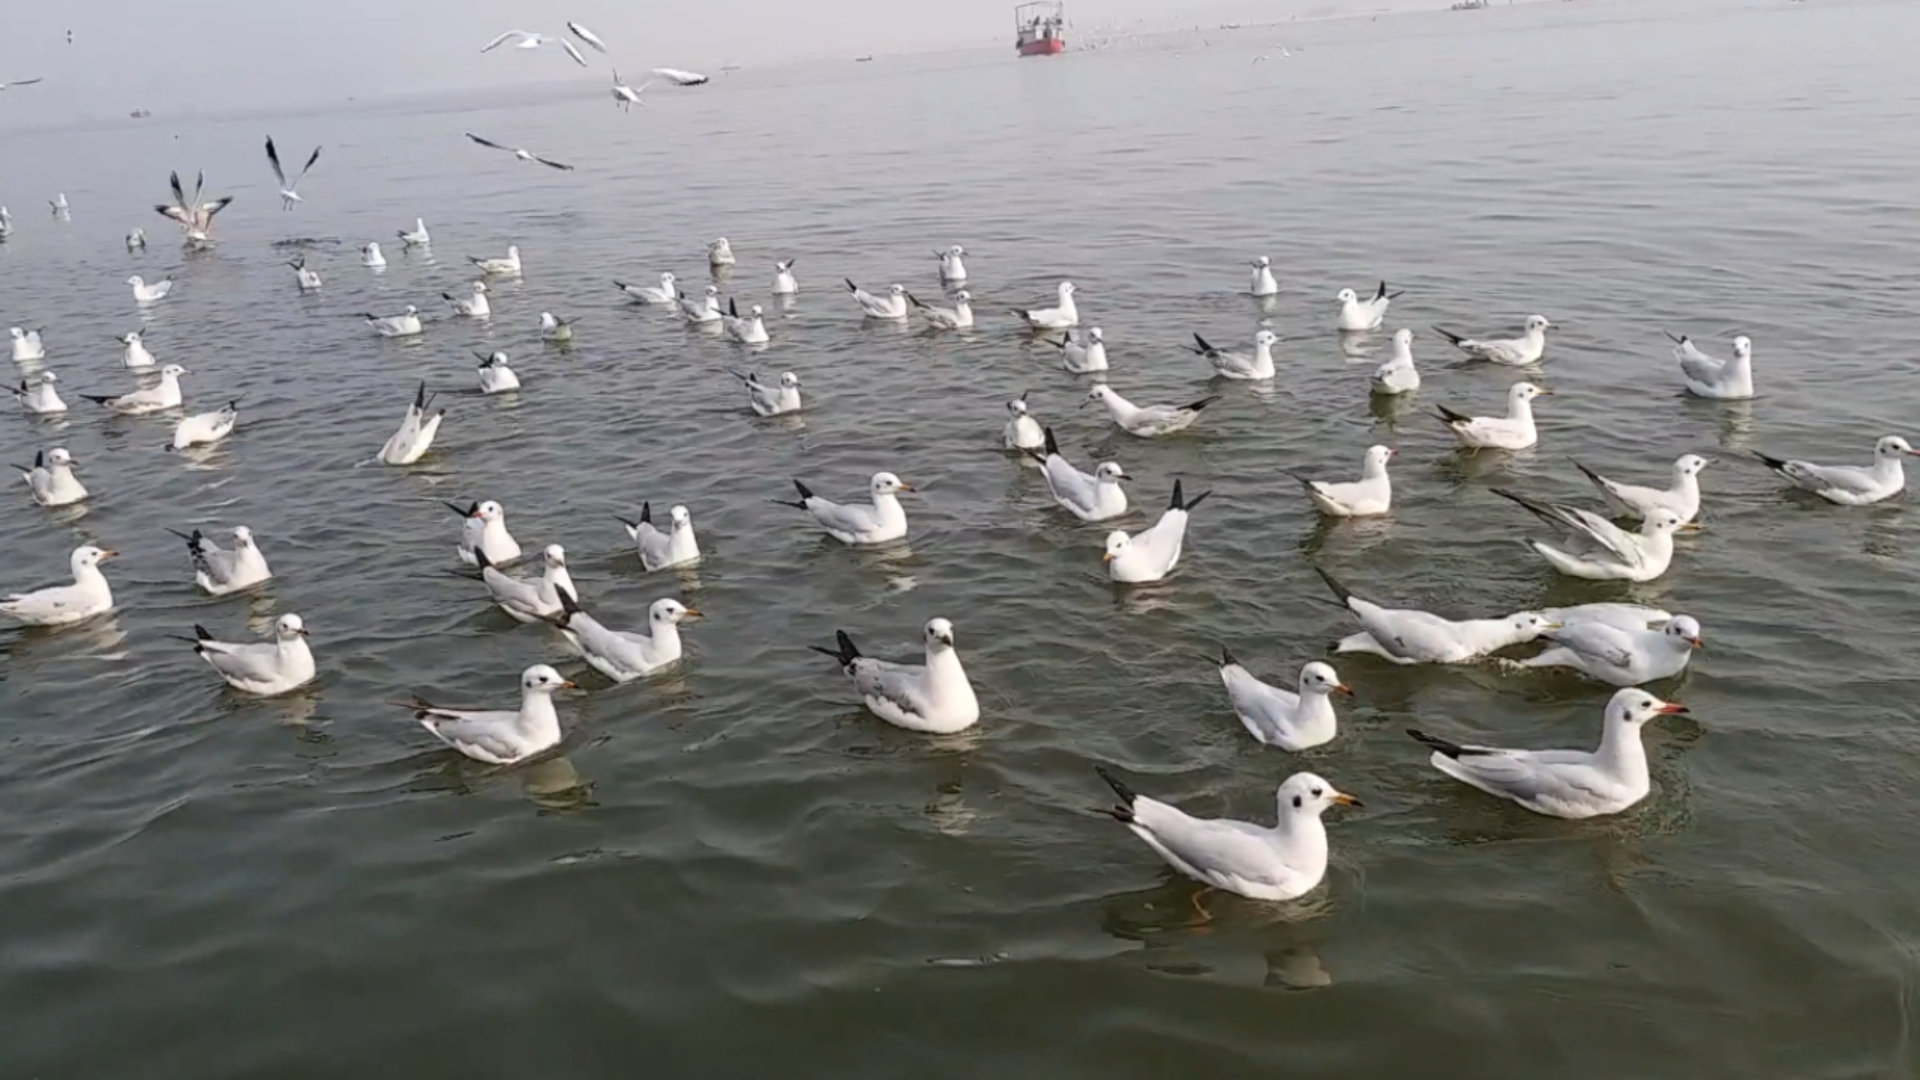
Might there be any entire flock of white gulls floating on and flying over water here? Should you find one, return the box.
[0,54,1916,899]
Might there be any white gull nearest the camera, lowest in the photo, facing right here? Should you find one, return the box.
[1094,765,1359,899]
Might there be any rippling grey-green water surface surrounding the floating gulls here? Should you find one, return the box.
[0,2,1920,1080]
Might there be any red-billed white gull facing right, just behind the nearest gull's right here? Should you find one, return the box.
[1407,688,1688,821]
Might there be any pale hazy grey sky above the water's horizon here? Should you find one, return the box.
[0,0,1446,127]
